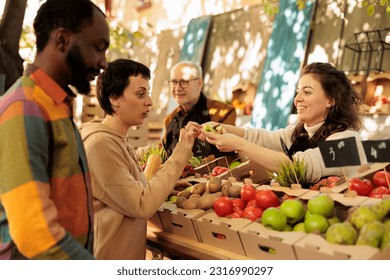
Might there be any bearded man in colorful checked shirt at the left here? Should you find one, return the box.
[0,0,110,259]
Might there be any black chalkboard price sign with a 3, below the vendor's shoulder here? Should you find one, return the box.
[318,137,361,168]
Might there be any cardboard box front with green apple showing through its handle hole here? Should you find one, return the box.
[239,223,306,260]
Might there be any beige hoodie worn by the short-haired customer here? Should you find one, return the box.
[79,120,192,260]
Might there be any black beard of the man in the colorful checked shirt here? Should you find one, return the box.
[65,45,96,94]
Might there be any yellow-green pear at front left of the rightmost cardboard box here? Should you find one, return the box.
[326,223,357,245]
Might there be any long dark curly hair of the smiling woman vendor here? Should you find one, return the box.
[291,62,361,152]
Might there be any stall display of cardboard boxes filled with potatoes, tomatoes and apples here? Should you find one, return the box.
[147,154,390,259]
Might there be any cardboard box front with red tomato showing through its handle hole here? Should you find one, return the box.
[196,211,251,256]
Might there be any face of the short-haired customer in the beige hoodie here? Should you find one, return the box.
[111,75,153,129]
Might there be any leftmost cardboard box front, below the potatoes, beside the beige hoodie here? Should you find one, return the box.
[158,203,206,241]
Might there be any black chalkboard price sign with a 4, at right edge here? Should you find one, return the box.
[362,139,390,162]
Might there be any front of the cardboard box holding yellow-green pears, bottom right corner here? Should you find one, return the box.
[293,234,390,260]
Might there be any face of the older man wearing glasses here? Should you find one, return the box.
[170,64,203,111]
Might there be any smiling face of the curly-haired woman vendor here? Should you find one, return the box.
[294,74,334,126]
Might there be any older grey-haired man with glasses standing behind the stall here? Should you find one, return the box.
[163,61,237,156]
